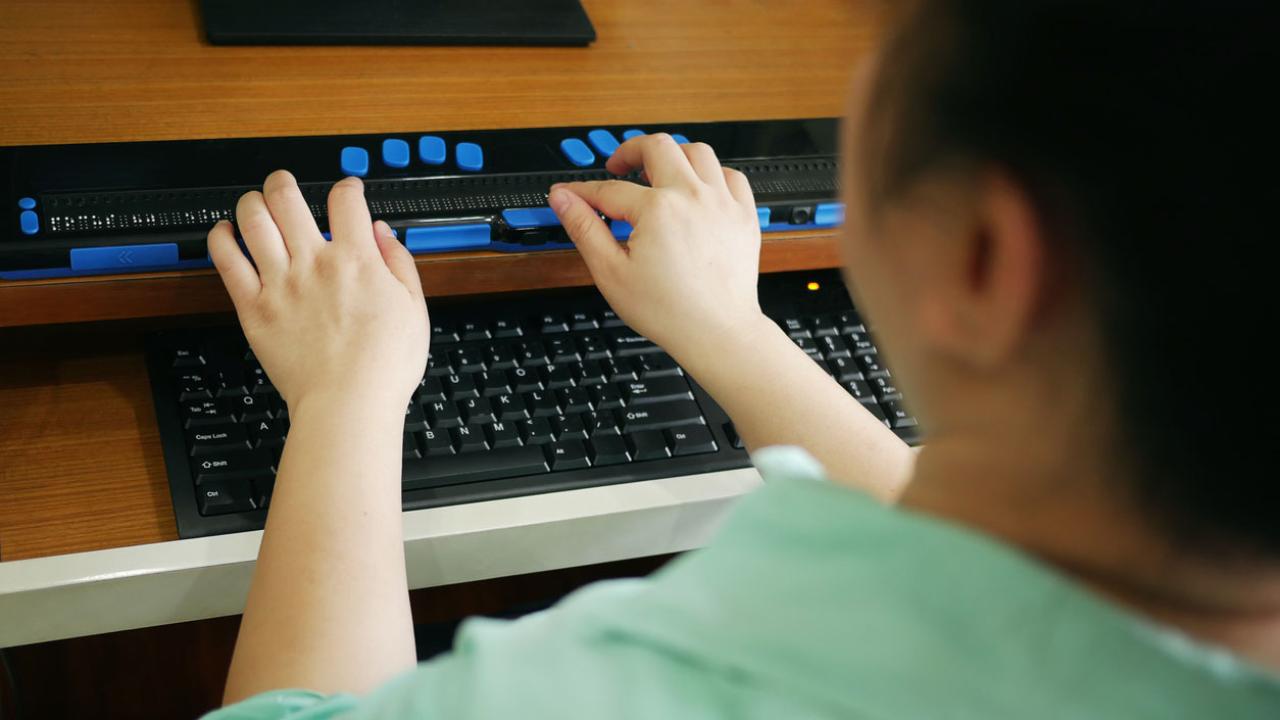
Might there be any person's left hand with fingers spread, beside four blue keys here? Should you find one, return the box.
[209,170,430,411]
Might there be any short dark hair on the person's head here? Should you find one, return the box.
[860,0,1280,557]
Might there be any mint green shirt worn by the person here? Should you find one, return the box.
[206,448,1280,720]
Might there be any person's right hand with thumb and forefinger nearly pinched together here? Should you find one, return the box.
[549,133,772,364]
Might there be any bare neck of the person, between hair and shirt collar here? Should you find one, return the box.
[901,422,1280,670]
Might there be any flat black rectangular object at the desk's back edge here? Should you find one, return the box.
[200,0,595,45]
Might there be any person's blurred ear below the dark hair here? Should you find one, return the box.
[920,173,1048,368]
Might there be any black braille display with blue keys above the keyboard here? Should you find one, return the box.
[0,118,842,279]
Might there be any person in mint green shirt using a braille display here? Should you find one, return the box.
[199,0,1280,720]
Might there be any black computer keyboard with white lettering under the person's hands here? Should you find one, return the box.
[147,270,919,537]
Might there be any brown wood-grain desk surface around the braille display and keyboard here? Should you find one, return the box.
[0,0,881,560]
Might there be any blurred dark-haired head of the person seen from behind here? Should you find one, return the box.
[844,0,1280,560]
